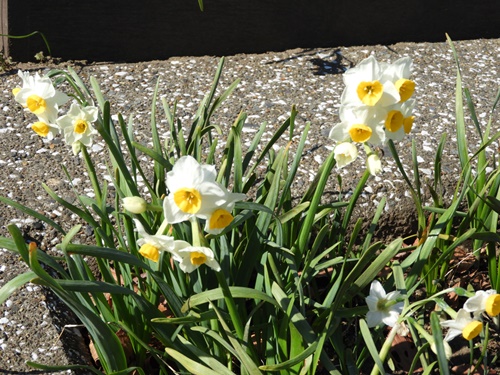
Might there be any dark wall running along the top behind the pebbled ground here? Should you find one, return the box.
[6,0,500,62]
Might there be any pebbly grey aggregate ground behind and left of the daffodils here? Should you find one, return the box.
[0,39,500,373]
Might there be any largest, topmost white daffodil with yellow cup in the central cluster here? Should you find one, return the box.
[163,156,245,224]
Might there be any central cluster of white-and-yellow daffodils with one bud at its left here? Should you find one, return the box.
[123,156,246,273]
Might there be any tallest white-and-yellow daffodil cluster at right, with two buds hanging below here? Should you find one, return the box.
[329,56,416,175]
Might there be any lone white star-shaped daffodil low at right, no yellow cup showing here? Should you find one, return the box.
[365,280,404,327]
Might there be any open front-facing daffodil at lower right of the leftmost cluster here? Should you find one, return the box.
[56,103,98,153]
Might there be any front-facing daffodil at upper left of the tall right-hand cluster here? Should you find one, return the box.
[341,56,401,107]
